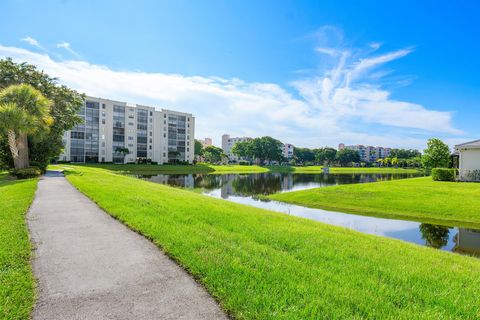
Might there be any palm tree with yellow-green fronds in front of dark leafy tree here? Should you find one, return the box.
[0,84,53,169]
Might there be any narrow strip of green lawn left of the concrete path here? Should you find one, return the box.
[0,174,37,319]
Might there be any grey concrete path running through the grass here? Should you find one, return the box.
[27,172,227,320]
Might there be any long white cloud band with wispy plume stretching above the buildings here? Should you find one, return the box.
[0,36,460,148]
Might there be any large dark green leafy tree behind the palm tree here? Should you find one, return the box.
[0,58,84,170]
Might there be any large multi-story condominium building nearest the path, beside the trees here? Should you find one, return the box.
[60,97,195,163]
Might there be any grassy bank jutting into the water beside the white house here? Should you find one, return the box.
[268,177,480,227]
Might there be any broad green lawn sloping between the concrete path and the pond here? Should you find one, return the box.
[62,167,480,320]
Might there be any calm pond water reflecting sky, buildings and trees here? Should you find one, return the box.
[139,173,480,255]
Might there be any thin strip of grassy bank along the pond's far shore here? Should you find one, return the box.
[54,163,418,174]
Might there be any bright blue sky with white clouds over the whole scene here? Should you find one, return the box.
[0,0,480,148]
